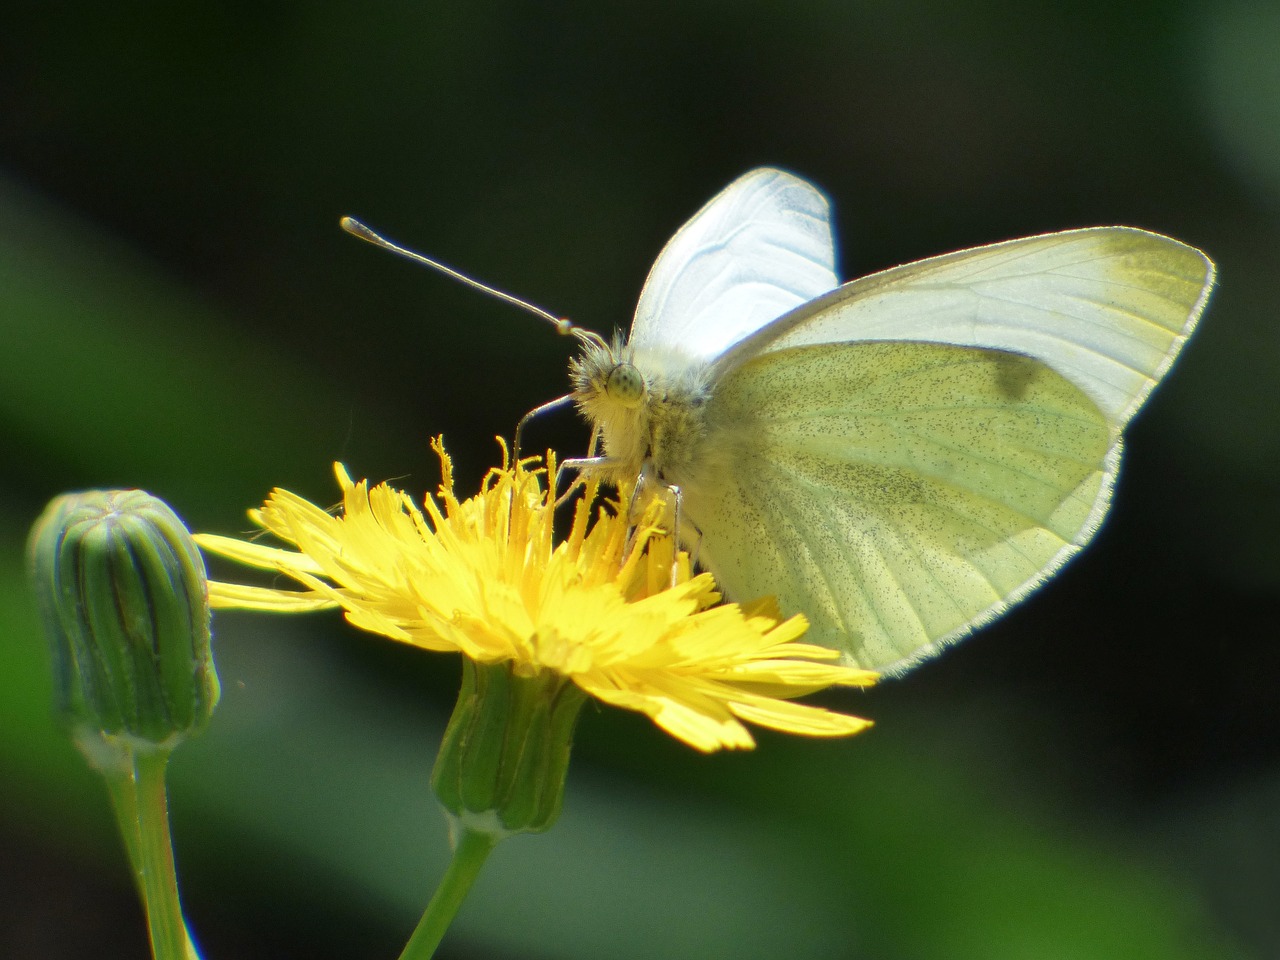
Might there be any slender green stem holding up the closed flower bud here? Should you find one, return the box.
[129,751,195,960]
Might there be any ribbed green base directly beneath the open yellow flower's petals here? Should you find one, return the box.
[431,658,586,837]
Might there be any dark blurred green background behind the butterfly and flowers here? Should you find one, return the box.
[0,0,1280,960]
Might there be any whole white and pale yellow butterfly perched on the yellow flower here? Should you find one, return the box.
[571,169,1213,671]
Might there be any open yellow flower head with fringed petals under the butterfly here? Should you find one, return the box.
[197,440,876,751]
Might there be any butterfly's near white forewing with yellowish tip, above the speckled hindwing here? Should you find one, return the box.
[721,227,1213,426]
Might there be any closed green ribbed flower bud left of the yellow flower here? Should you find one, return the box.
[28,490,219,762]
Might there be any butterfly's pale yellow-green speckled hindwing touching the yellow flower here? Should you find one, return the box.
[682,342,1119,669]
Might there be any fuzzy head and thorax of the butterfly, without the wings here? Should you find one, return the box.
[570,337,709,484]
